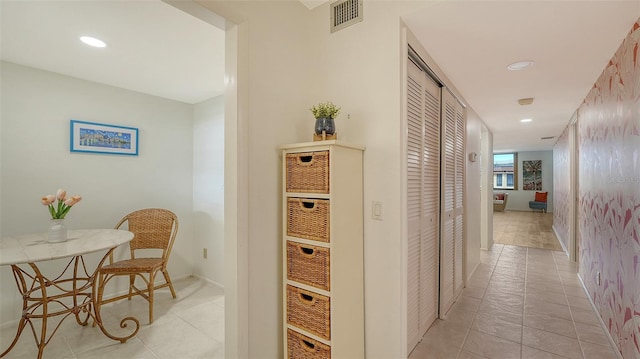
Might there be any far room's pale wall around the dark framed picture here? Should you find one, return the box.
[494,151,553,213]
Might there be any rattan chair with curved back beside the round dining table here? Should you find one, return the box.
[96,208,178,324]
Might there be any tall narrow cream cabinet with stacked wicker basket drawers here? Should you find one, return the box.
[282,140,364,359]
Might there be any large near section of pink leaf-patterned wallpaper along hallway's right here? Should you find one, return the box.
[576,20,640,358]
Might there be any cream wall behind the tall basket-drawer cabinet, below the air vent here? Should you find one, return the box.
[199,1,492,358]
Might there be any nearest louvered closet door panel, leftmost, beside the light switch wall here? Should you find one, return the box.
[406,60,440,352]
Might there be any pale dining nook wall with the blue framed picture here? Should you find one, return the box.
[0,62,194,323]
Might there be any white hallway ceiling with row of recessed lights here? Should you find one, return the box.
[402,0,640,151]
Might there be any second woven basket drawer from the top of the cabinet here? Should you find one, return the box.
[287,198,329,242]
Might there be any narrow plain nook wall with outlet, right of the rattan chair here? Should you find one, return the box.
[193,96,224,285]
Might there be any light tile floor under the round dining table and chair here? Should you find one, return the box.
[0,277,224,359]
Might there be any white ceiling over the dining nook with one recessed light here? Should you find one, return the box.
[0,0,224,104]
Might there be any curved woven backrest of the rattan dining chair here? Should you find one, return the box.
[116,208,178,261]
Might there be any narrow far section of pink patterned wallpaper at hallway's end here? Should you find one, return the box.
[553,127,571,253]
